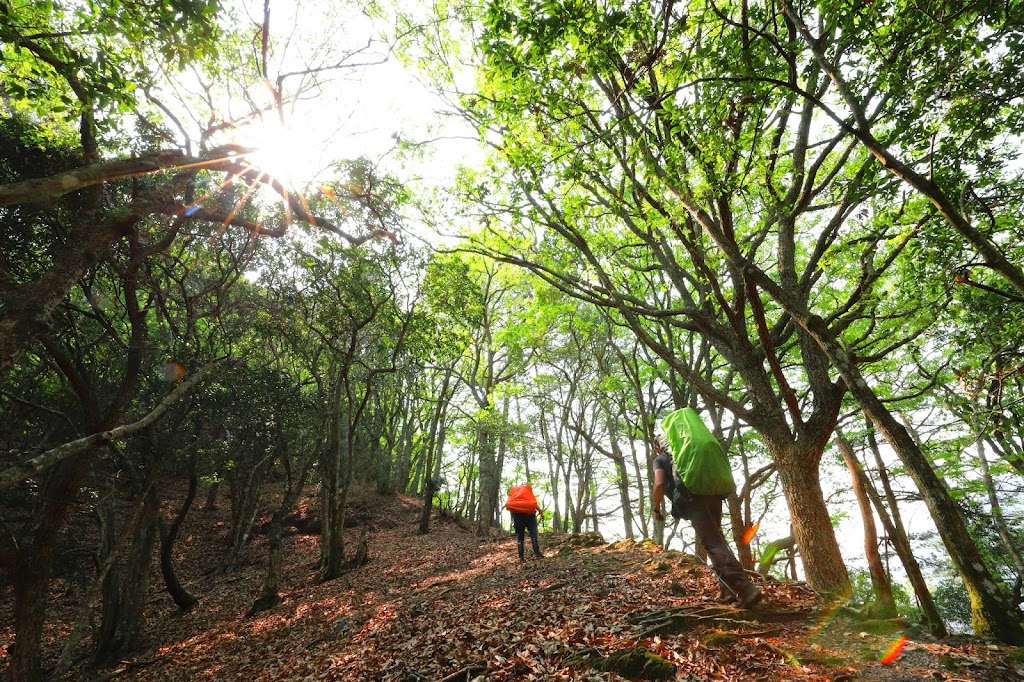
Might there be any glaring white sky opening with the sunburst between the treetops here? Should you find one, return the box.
[212,0,476,196]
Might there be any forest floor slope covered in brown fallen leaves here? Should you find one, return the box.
[0,485,1024,682]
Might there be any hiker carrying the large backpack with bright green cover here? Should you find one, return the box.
[651,408,761,608]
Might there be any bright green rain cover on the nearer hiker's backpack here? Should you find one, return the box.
[662,408,736,495]
